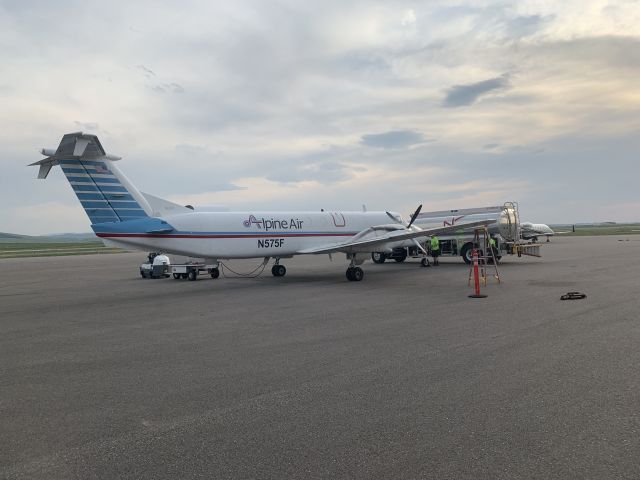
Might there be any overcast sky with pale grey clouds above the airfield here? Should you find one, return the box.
[0,0,640,234]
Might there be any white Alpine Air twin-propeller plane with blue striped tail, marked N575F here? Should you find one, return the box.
[31,132,487,281]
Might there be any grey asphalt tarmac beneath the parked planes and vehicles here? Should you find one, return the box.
[0,235,640,479]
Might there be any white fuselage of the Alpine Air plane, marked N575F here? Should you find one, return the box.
[96,211,402,259]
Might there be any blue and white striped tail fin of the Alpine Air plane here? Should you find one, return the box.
[31,132,153,224]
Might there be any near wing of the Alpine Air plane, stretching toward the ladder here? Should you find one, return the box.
[297,220,493,255]
